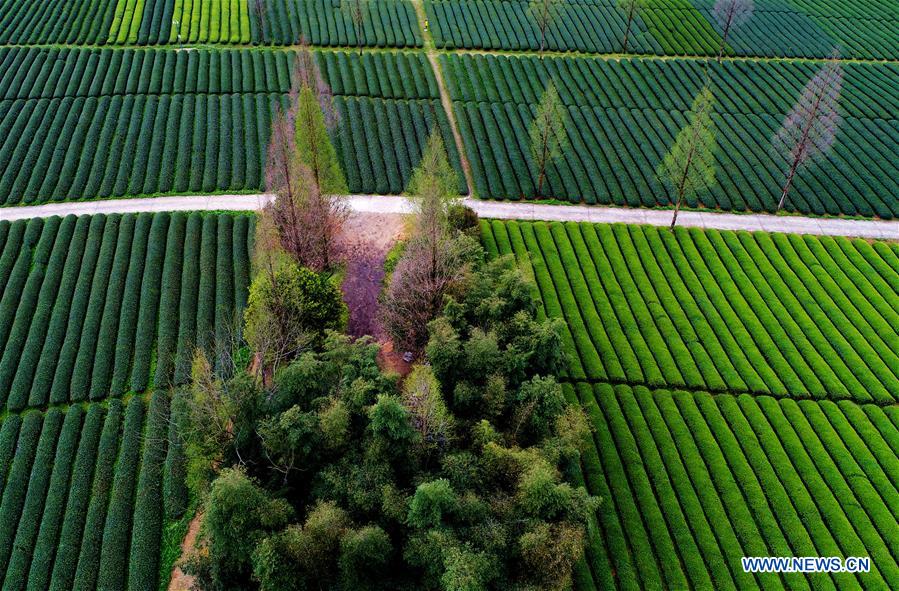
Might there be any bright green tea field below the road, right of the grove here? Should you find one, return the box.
[481,221,899,589]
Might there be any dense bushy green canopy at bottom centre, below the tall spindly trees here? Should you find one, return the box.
[182,243,598,590]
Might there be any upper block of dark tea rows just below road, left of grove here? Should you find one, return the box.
[0,213,252,411]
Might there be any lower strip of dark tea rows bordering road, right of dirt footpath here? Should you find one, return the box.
[454,102,899,219]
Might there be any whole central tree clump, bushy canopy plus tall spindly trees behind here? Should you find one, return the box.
[173,86,599,591]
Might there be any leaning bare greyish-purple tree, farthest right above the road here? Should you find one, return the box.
[771,53,843,211]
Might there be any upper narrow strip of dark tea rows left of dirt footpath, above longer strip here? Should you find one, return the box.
[0,47,440,100]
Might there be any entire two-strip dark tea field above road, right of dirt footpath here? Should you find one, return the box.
[450,55,899,218]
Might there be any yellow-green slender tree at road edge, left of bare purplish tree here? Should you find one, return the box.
[656,84,716,229]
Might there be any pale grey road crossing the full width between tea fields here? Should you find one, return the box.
[0,194,899,241]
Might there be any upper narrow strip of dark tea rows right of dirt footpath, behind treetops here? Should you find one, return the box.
[440,54,899,120]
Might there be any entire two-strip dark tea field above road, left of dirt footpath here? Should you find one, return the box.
[0,48,466,205]
